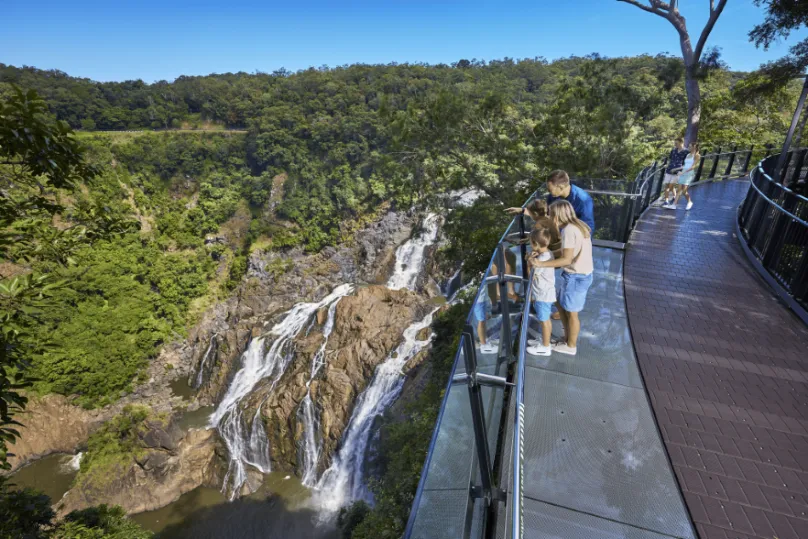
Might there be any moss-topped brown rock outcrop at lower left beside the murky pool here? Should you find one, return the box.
[57,407,221,514]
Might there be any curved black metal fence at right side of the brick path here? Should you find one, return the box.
[738,153,808,316]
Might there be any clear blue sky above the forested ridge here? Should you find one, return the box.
[0,0,808,82]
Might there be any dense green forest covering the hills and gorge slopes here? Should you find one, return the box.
[0,55,798,537]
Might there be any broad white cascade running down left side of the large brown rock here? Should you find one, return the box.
[210,284,353,499]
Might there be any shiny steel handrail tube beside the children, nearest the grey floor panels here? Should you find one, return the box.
[510,270,535,539]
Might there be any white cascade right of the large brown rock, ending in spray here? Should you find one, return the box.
[314,308,437,515]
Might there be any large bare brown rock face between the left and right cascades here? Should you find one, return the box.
[241,285,425,474]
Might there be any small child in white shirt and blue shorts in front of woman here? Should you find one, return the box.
[527,228,555,356]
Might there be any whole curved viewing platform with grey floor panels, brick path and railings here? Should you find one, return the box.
[405,150,808,539]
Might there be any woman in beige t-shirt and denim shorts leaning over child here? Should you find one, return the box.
[533,200,595,356]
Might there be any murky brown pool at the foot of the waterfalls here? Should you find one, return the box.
[132,473,338,539]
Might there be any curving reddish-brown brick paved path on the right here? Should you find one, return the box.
[625,180,808,539]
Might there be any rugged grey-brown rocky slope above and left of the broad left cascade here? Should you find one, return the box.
[184,212,413,404]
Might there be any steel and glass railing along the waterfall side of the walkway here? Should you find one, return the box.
[404,143,753,539]
